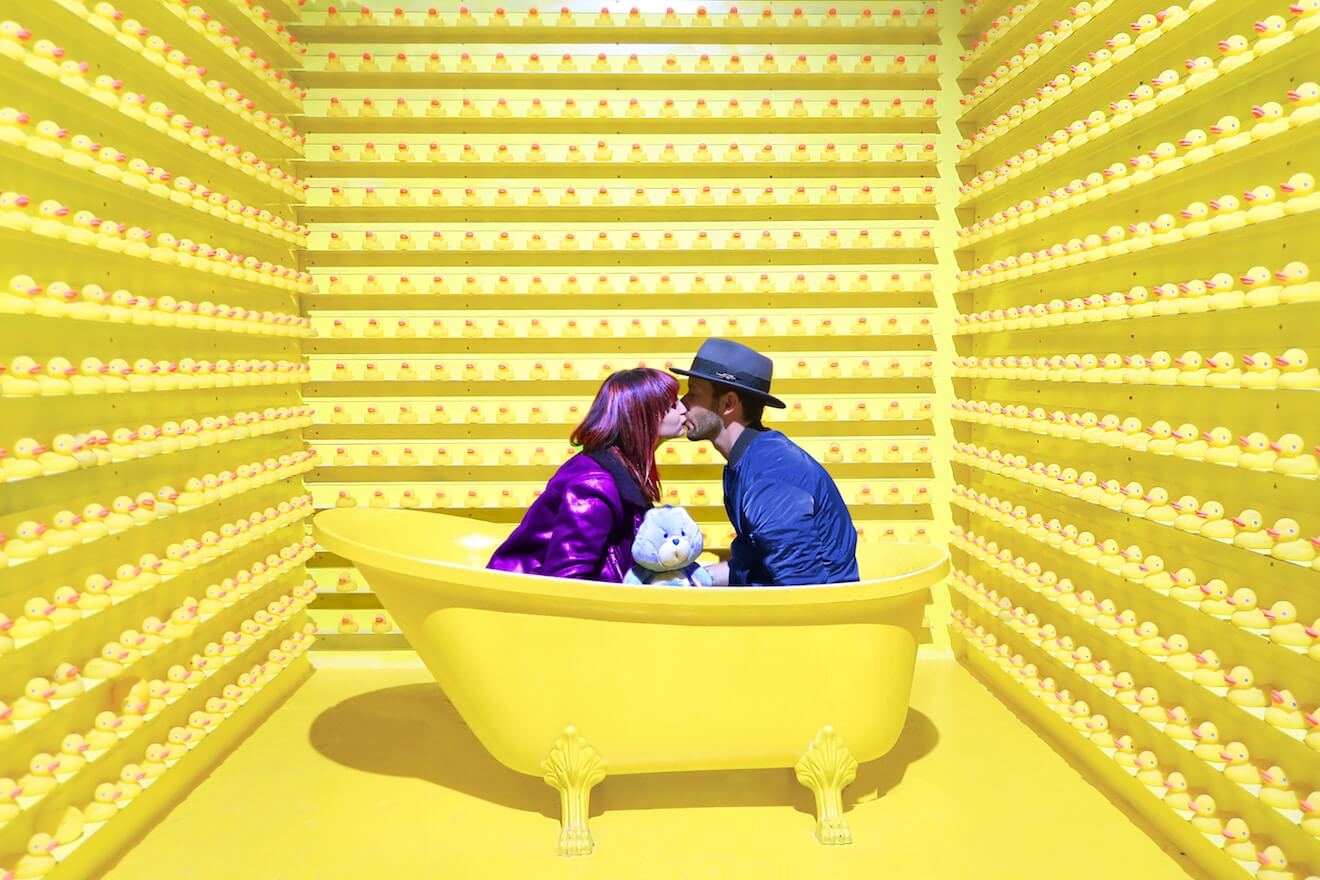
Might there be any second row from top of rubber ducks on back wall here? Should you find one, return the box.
[319,51,940,77]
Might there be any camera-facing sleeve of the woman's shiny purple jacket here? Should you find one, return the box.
[541,475,623,581]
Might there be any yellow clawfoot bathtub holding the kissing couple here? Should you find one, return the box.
[315,509,948,855]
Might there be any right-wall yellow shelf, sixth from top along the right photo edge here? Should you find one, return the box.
[954,422,1320,519]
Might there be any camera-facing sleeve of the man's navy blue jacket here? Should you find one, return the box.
[730,479,822,587]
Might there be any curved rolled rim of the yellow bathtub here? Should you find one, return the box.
[313,509,949,613]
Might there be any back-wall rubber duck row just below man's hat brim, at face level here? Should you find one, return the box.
[320,398,933,433]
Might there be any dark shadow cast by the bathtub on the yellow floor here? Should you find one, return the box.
[309,683,940,819]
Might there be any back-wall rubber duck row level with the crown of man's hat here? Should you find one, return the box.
[317,358,933,382]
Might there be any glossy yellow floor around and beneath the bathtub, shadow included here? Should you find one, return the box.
[106,660,1188,880]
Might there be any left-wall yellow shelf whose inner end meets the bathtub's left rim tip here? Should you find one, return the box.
[0,520,306,701]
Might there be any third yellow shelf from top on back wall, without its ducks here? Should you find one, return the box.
[293,116,940,137]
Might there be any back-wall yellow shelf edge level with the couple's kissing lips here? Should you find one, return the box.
[302,420,935,443]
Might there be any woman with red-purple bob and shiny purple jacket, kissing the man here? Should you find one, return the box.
[487,367,688,583]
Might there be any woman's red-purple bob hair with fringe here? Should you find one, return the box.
[572,367,678,501]
